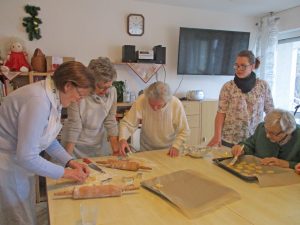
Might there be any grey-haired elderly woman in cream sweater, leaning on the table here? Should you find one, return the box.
[119,81,190,157]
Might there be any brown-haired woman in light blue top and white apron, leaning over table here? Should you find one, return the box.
[0,61,94,225]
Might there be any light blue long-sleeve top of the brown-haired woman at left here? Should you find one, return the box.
[0,81,71,179]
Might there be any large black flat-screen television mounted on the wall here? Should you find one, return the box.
[177,27,250,75]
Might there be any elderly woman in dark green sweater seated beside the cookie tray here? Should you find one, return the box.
[232,109,300,168]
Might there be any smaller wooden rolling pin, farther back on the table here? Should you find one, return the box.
[96,159,152,171]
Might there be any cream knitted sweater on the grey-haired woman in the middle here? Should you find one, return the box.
[119,94,190,150]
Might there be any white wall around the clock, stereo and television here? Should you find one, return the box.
[0,0,294,98]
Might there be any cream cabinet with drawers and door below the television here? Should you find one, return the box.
[182,100,218,145]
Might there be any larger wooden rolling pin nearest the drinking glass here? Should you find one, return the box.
[54,184,139,199]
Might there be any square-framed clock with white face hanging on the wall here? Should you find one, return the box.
[127,14,145,36]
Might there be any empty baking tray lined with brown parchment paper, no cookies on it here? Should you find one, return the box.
[141,170,240,218]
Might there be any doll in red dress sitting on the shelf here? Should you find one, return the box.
[1,42,30,72]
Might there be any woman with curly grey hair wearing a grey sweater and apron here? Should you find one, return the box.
[62,57,119,158]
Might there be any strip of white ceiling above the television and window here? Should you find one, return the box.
[136,0,300,17]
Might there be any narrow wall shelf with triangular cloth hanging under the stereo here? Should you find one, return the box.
[114,62,164,83]
